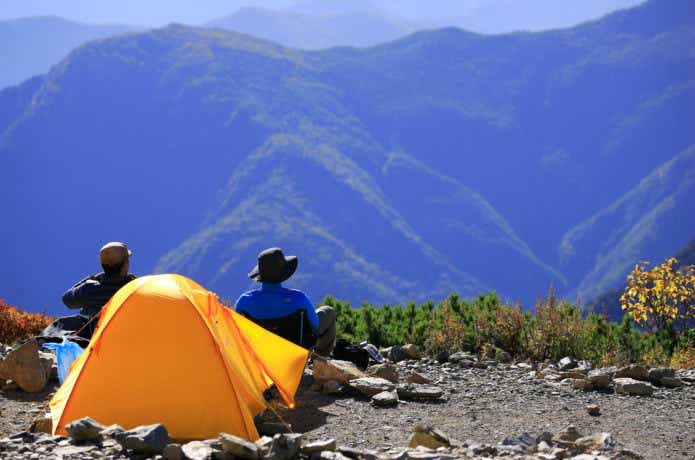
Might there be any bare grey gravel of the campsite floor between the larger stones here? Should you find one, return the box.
[0,362,695,459]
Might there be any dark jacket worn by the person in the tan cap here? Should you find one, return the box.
[63,272,136,317]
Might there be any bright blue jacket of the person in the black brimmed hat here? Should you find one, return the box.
[236,283,319,331]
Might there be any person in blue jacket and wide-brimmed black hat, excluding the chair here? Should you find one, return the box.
[236,248,336,356]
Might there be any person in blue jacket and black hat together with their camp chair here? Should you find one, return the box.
[236,248,336,356]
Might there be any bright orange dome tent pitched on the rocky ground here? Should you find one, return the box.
[50,275,308,441]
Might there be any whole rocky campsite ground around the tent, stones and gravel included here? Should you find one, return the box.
[0,344,695,460]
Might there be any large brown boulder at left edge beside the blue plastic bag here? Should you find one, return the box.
[0,340,54,393]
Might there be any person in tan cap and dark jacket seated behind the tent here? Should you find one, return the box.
[40,241,136,341]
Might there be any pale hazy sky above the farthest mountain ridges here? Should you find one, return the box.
[0,0,642,31]
